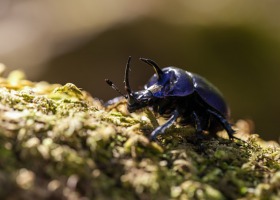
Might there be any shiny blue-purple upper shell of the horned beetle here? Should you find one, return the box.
[144,67,230,119]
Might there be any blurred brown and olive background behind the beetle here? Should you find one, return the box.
[0,0,280,140]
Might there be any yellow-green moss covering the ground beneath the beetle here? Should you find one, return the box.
[0,71,280,199]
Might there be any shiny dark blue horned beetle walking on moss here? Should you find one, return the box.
[105,57,238,140]
